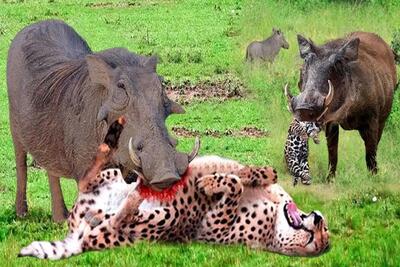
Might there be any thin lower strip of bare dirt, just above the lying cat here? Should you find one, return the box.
[172,126,269,138]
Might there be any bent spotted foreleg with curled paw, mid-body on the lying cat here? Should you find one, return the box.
[196,173,243,243]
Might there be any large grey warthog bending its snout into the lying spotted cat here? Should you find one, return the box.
[7,20,198,221]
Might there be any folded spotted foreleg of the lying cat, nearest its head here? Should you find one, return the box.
[237,166,278,187]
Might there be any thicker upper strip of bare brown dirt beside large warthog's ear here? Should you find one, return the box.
[164,76,246,104]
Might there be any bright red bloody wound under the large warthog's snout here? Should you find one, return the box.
[138,168,190,201]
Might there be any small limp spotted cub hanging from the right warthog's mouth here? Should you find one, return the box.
[284,118,322,186]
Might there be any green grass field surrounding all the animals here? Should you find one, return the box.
[0,0,400,266]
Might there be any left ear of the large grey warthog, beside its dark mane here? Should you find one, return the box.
[86,55,113,87]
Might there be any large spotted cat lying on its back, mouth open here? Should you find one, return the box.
[18,116,330,260]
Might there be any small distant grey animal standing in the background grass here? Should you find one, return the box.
[246,28,289,63]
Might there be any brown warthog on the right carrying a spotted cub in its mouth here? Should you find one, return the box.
[285,32,397,177]
